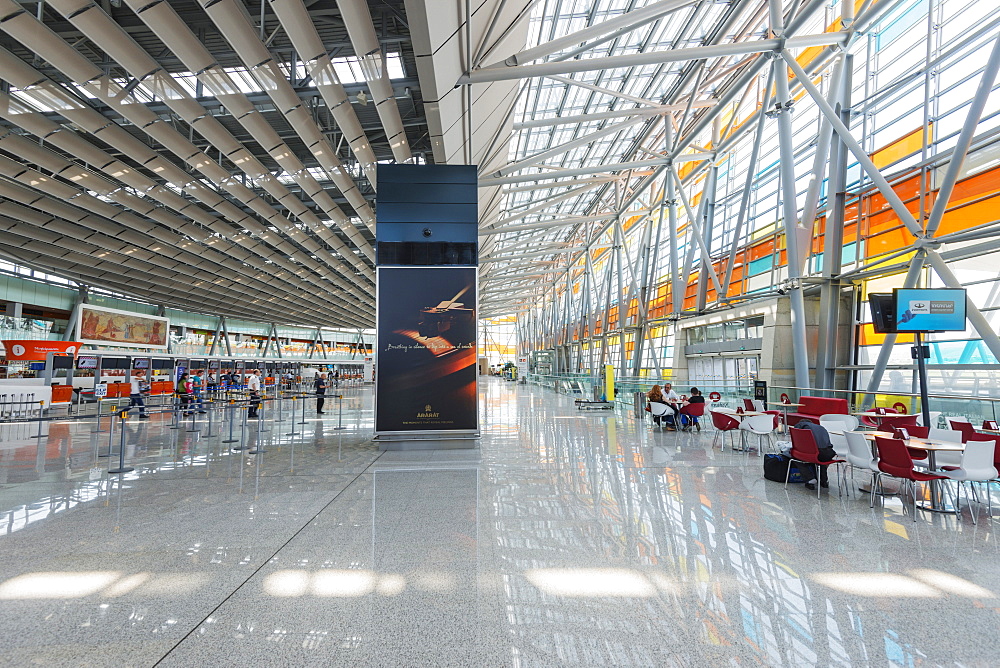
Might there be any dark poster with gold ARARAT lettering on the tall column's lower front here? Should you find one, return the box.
[375,267,479,432]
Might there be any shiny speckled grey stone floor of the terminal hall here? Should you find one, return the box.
[0,378,1000,667]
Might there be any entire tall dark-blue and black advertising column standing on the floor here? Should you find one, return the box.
[375,165,479,450]
